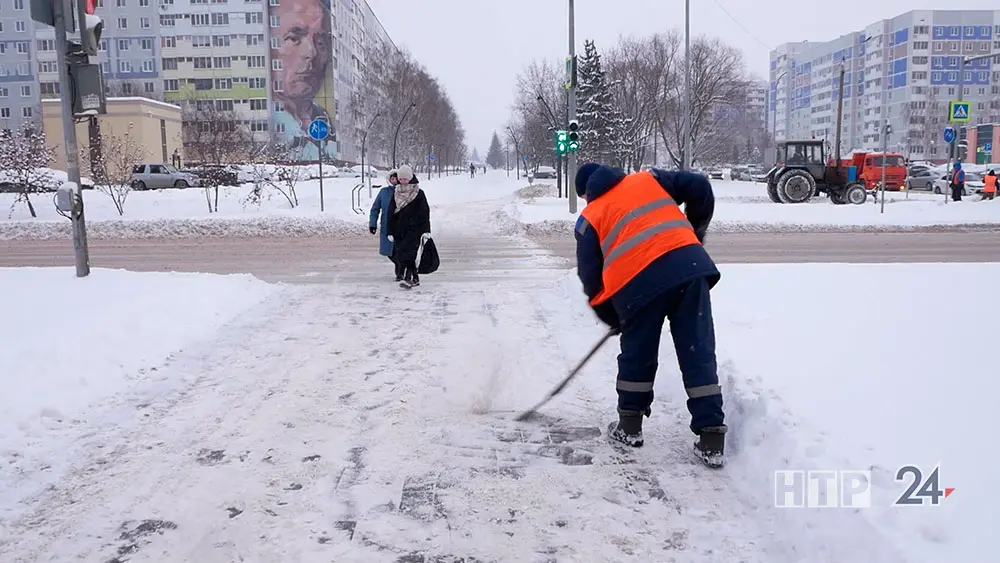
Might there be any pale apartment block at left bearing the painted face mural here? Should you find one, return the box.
[0,0,392,162]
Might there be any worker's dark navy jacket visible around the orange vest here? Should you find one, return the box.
[576,166,721,322]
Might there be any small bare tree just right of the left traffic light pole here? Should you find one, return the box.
[80,123,147,216]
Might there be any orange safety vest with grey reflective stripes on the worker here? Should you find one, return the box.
[580,171,701,306]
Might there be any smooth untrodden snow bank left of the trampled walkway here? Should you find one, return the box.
[0,268,274,521]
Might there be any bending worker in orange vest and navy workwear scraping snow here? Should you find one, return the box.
[575,162,726,467]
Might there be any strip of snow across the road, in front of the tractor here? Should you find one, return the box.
[506,180,1000,234]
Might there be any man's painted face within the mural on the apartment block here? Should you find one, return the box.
[277,0,333,100]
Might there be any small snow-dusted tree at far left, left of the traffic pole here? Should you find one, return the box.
[0,127,55,217]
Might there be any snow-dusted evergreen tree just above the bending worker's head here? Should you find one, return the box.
[577,40,629,166]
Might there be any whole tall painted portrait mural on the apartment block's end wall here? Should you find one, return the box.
[268,0,336,160]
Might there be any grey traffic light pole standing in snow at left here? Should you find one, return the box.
[52,0,90,278]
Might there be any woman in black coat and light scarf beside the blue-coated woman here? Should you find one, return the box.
[389,164,431,289]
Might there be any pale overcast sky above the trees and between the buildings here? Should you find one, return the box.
[368,0,991,155]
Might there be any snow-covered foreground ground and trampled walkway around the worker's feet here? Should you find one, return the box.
[0,172,1000,563]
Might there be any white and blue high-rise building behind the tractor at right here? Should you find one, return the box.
[768,10,1000,160]
